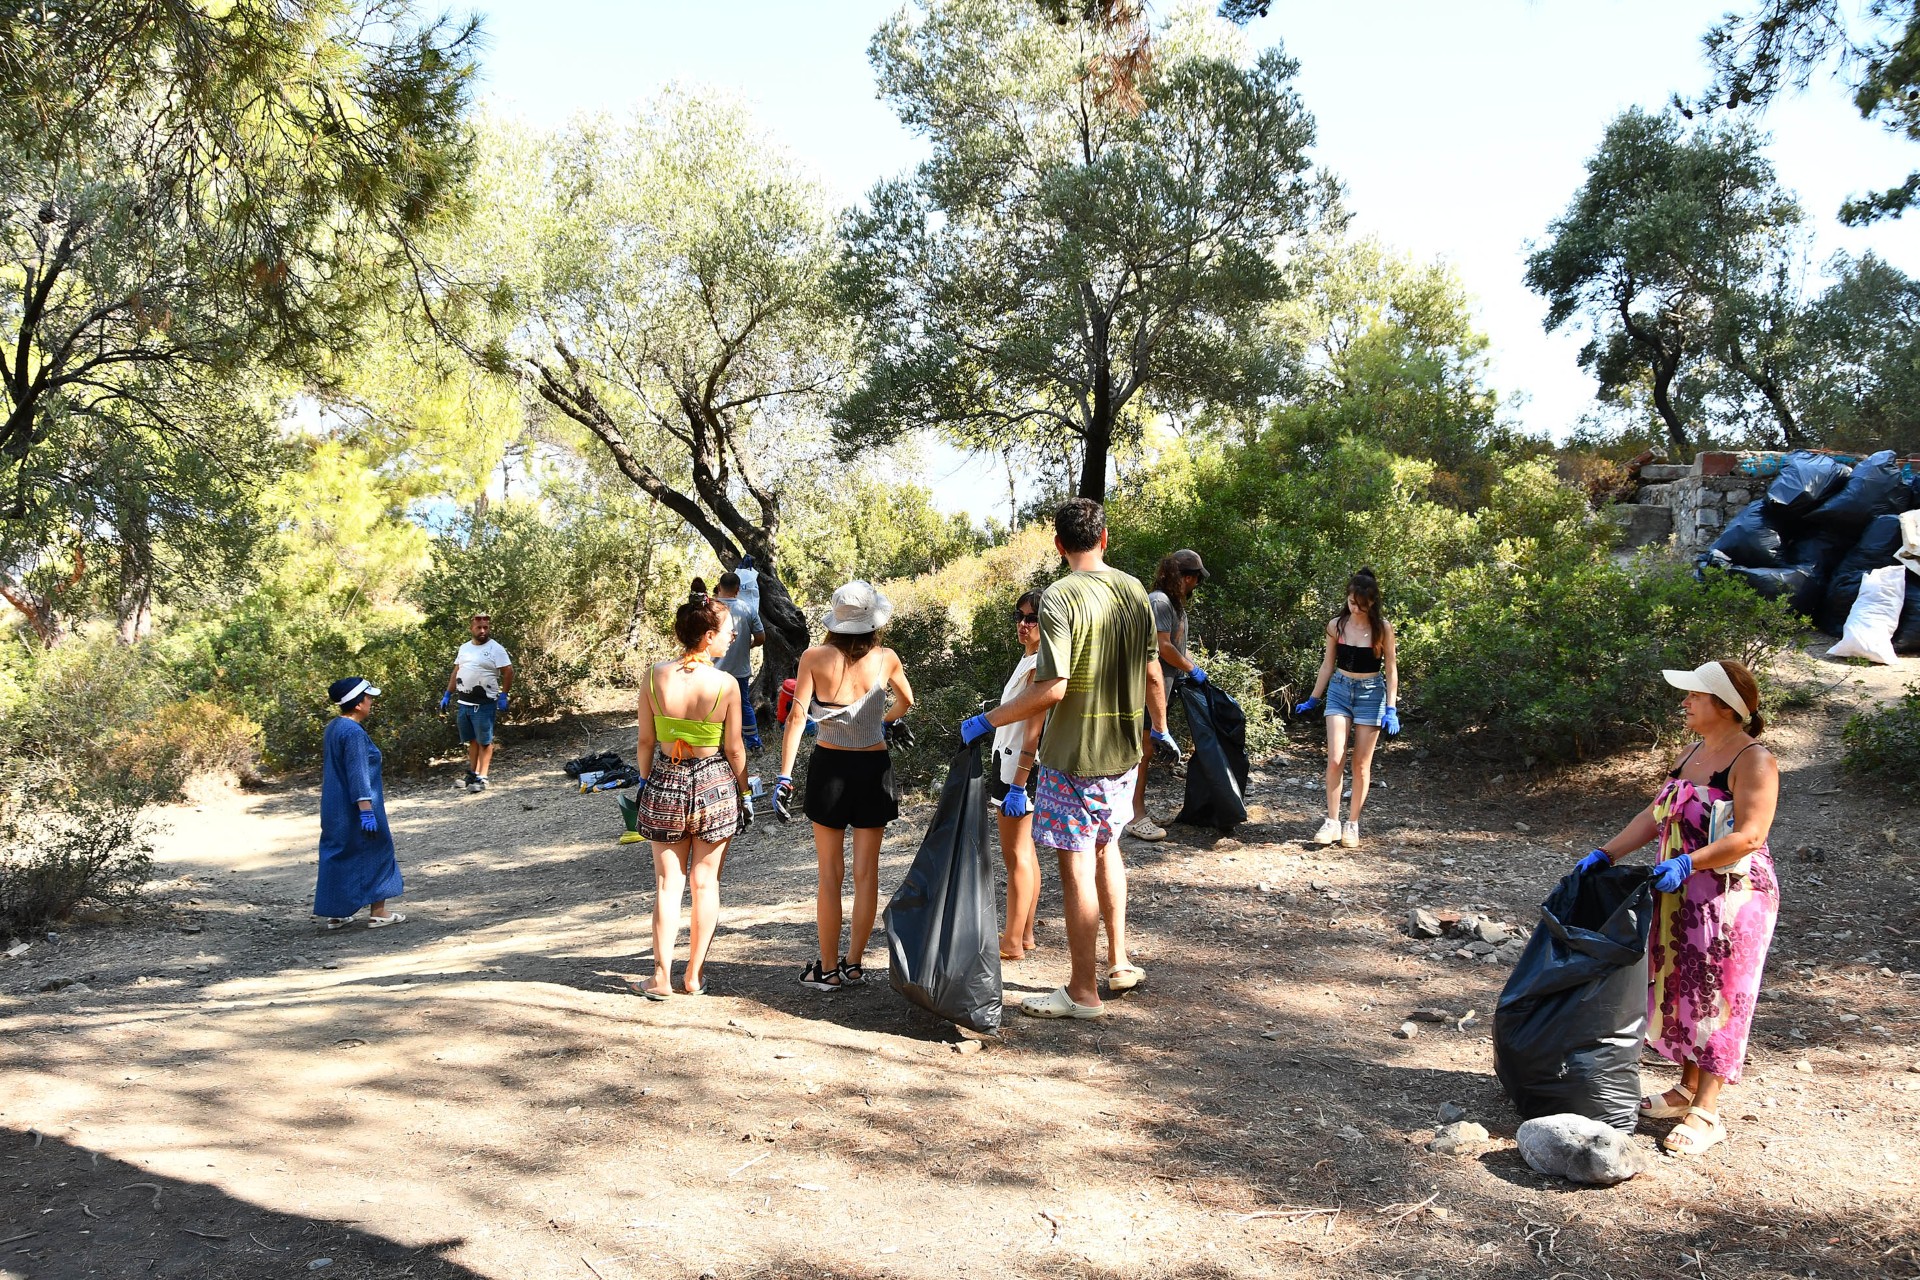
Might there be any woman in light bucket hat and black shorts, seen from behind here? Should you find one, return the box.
[774,580,914,990]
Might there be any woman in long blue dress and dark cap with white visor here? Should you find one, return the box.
[313,676,407,929]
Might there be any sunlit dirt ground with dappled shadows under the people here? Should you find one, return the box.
[0,664,1920,1280]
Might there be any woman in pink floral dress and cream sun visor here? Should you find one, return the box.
[1580,662,1780,1155]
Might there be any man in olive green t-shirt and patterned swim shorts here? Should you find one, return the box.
[960,497,1177,1017]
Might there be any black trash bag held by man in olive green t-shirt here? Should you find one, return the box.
[885,745,1000,1036]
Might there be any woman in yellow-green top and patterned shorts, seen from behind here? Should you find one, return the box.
[637,593,753,1000]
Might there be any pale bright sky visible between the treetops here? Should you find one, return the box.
[464,0,1920,518]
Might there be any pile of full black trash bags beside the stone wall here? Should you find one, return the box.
[1695,449,1920,652]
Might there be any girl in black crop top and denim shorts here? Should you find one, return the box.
[1294,568,1400,848]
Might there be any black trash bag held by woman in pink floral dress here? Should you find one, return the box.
[1494,865,1653,1132]
